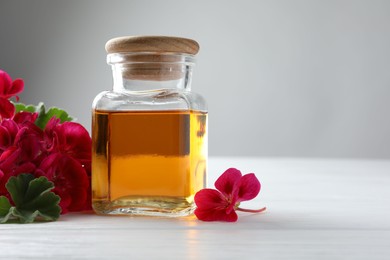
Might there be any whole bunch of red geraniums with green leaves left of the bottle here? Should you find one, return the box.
[0,70,91,223]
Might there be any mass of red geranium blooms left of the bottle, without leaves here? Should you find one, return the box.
[0,70,91,217]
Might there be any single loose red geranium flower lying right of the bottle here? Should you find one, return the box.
[194,168,265,222]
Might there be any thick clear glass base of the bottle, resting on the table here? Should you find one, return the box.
[92,196,196,217]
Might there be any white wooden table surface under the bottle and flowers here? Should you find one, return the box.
[0,158,390,260]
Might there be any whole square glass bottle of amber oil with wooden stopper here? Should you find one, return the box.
[92,36,207,216]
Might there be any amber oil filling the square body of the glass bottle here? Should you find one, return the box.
[92,110,207,216]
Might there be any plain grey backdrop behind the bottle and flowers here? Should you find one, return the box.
[0,0,390,159]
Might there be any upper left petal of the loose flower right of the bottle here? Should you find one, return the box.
[214,168,242,200]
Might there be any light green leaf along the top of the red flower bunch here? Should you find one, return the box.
[14,102,74,129]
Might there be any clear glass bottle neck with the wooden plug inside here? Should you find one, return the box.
[107,53,195,92]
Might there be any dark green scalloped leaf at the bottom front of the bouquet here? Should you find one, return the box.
[0,174,61,223]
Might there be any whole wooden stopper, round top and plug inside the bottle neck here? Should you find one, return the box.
[106,36,199,81]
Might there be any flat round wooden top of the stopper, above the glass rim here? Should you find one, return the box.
[106,36,199,55]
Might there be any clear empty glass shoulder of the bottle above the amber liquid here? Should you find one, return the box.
[92,90,207,112]
